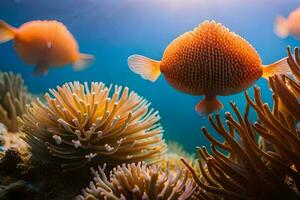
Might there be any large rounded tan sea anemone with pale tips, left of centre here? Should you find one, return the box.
[20,82,166,170]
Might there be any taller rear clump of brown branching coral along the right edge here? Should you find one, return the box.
[247,47,300,172]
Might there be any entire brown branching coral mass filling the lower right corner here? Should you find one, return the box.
[182,46,300,199]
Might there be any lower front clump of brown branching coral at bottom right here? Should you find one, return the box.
[183,103,300,199]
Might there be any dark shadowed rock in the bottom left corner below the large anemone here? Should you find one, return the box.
[0,146,90,200]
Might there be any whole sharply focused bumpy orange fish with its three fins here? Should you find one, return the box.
[128,21,289,115]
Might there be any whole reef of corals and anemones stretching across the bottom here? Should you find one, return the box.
[0,48,300,200]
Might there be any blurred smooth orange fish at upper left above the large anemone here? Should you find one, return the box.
[0,20,93,75]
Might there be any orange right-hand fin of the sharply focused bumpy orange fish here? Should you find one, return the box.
[262,58,291,79]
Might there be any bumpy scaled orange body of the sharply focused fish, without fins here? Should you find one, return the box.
[161,21,263,95]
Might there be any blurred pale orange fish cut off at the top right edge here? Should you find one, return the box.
[274,7,300,39]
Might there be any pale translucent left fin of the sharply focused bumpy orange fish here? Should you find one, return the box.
[128,55,161,82]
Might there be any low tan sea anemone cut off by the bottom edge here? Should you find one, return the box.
[77,162,196,200]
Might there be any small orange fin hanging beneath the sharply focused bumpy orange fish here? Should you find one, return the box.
[195,96,224,116]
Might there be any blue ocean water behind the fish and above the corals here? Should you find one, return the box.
[0,0,300,152]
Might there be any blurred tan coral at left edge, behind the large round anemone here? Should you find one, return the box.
[0,72,32,132]
